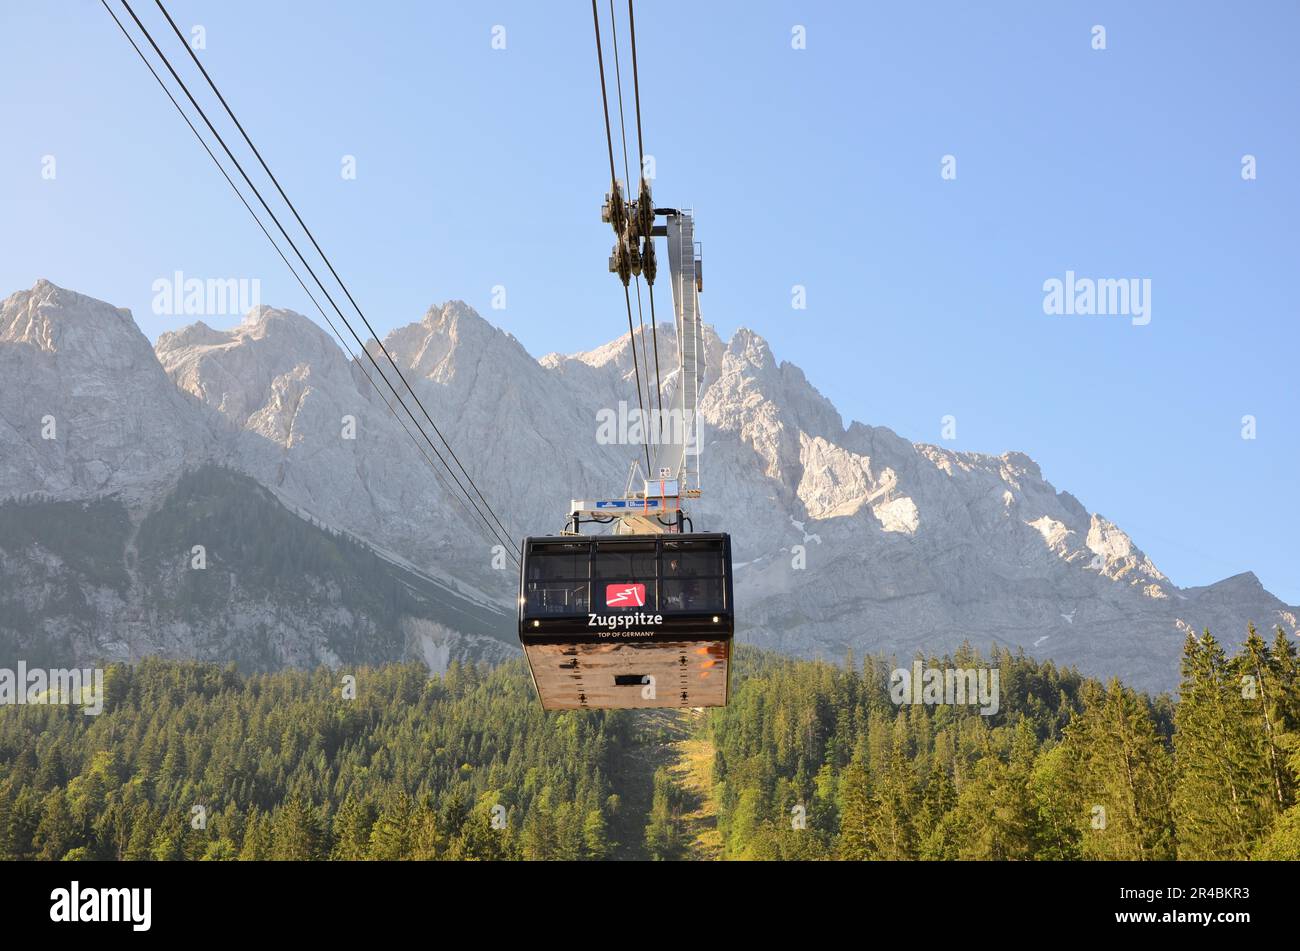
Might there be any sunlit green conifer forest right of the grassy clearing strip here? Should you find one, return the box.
[712,629,1300,860]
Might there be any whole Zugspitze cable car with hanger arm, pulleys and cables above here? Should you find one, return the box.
[519,5,735,709]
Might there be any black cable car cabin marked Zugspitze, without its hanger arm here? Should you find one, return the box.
[519,533,735,709]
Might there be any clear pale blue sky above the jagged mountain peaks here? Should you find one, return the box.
[0,0,1300,603]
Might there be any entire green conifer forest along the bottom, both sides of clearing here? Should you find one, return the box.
[0,631,1300,860]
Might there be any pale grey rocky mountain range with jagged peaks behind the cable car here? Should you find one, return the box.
[0,282,1300,689]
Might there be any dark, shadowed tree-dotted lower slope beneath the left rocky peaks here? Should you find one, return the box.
[0,465,517,672]
